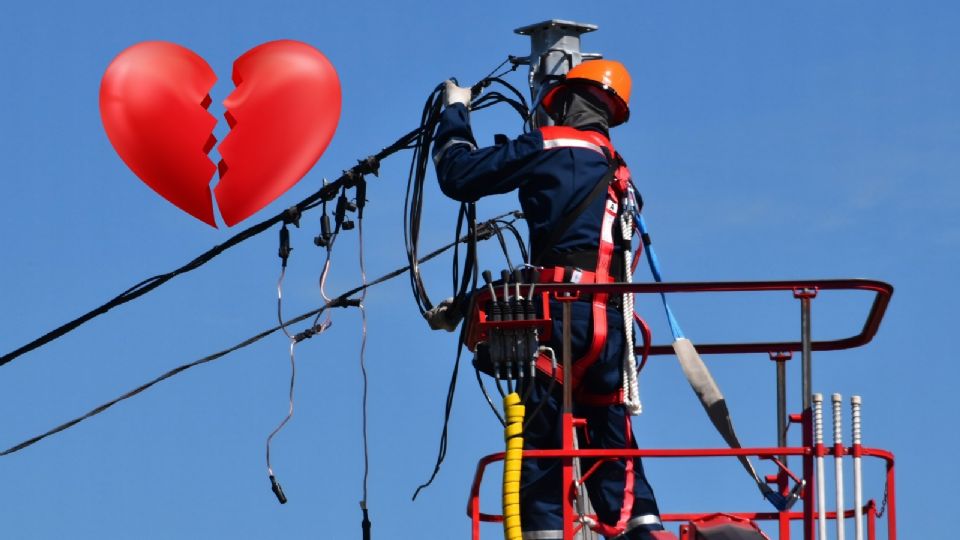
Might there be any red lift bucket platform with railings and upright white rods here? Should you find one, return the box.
[467,279,897,540]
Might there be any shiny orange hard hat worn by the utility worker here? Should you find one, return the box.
[541,60,631,126]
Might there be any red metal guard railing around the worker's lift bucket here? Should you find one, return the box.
[467,279,896,540]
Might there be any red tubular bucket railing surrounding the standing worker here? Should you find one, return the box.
[467,279,896,540]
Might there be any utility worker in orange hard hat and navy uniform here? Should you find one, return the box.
[428,60,663,540]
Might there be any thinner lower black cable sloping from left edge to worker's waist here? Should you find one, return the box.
[0,212,515,457]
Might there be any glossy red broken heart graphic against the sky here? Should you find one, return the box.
[100,40,340,227]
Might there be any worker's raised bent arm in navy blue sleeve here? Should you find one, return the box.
[433,102,543,202]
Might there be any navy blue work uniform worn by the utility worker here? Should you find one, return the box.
[434,104,662,539]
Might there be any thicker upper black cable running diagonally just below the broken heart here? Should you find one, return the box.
[0,127,422,366]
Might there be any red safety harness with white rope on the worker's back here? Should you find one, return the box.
[533,126,640,414]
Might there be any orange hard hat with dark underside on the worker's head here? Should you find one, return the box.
[541,60,631,127]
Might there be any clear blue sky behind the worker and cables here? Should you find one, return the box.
[0,0,960,539]
